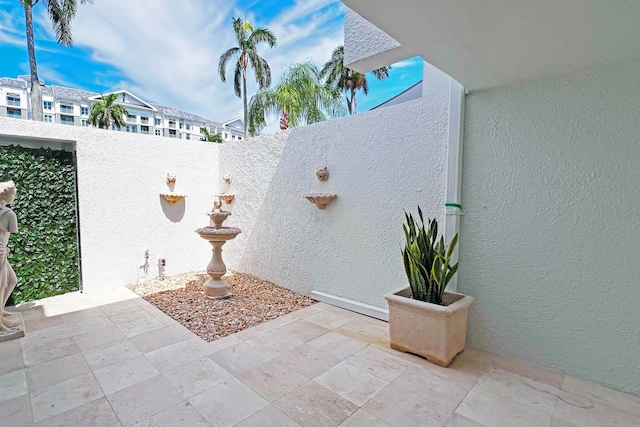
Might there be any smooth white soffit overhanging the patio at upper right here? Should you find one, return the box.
[342,0,640,90]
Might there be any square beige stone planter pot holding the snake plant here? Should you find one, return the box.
[385,287,474,366]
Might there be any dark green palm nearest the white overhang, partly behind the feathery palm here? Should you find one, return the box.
[321,46,391,114]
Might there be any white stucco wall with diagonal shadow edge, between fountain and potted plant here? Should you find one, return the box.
[220,96,448,308]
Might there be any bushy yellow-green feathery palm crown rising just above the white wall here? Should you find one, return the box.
[249,62,344,135]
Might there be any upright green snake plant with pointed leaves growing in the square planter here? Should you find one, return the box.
[402,206,458,305]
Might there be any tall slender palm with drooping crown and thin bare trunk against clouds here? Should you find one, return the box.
[218,18,276,135]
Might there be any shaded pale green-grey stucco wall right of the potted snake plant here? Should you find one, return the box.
[459,57,640,395]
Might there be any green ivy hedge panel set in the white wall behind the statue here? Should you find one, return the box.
[0,145,80,304]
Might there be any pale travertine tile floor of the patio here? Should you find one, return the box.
[0,289,640,427]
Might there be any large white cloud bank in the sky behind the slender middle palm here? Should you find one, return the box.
[63,0,344,132]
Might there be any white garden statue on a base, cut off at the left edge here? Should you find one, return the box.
[0,181,24,341]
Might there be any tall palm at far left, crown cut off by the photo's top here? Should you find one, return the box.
[20,0,93,121]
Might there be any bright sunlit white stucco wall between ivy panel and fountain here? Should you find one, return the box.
[0,118,219,292]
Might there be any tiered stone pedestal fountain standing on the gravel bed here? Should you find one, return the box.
[196,199,241,299]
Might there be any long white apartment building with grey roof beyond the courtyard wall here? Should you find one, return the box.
[0,76,244,141]
